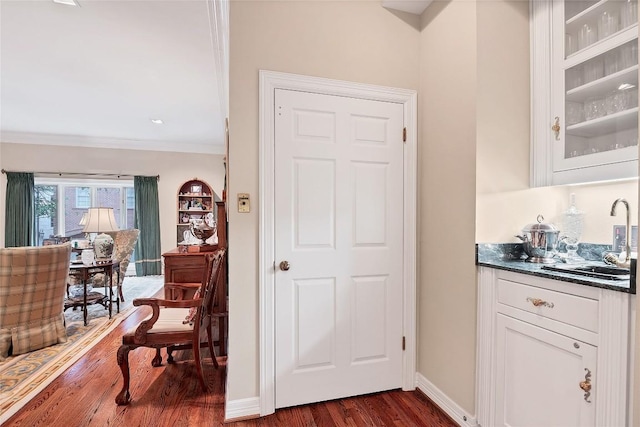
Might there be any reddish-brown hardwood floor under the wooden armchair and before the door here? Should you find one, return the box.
[3,309,457,427]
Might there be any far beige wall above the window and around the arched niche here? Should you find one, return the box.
[0,143,224,252]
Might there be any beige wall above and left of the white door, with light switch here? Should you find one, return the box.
[227,1,419,400]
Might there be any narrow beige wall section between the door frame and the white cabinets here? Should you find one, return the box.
[418,2,478,414]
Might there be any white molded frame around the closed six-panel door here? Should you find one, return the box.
[258,70,417,416]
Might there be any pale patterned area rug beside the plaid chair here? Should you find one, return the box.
[0,276,164,424]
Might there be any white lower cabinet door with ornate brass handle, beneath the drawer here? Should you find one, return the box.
[495,314,597,427]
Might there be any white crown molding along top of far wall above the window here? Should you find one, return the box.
[0,131,224,154]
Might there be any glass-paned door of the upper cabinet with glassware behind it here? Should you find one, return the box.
[552,0,638,178]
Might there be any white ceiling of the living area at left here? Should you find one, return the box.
[0,0,228,153]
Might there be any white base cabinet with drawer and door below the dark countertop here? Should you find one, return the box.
[477,267,630,427]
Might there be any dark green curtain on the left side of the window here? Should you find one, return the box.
[4,172,36,248]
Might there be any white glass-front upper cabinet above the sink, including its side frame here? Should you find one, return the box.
[531,0,638,186]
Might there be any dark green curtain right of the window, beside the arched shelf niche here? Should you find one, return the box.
[133,176,162,276]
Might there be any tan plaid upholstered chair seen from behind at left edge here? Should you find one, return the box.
[0,243,71,360]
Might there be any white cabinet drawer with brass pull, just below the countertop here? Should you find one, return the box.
[498,279,599,333]
